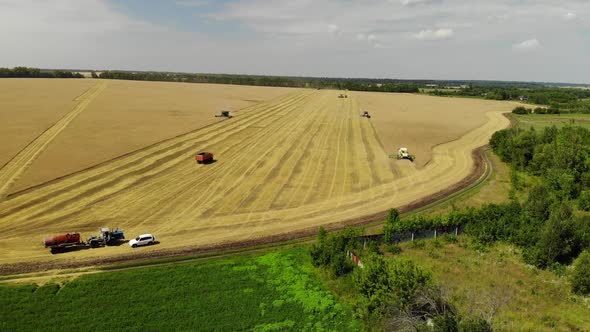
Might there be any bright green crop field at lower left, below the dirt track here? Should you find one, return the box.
[0,247,360,331]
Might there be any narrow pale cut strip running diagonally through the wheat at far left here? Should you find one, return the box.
[0,81,108,201]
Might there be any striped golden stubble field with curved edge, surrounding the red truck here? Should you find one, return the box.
[0,82,514,270]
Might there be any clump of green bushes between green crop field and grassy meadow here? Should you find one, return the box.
[310,227,490,331]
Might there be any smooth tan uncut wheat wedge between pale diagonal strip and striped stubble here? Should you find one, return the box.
[10,80,297,192]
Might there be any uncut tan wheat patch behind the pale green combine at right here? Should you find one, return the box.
[354,92,515,168]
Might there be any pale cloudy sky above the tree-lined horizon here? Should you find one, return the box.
[0,0,590,83]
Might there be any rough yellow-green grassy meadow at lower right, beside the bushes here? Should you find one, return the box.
[401,236,590,331]
